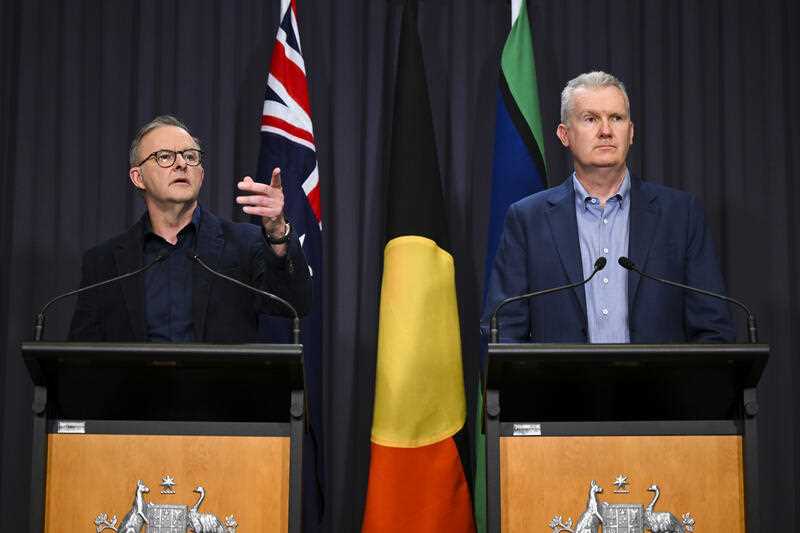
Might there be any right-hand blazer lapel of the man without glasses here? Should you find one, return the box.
[628,177,661,308]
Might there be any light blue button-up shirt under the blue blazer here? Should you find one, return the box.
[572,171,631,343]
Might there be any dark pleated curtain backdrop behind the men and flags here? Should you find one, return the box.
[0,0,800,532]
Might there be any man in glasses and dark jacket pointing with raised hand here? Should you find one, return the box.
[70,116,311,343]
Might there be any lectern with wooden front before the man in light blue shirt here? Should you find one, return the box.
[486,344,769,533]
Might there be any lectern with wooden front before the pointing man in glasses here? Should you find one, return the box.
[22,342,305,533]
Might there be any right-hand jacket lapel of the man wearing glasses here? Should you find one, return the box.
[192,209,225,336]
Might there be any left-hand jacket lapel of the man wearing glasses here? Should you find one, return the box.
[114,220,147,342]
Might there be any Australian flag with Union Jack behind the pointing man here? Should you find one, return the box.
[258,0,322,531]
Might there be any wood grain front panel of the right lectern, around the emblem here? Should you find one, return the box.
[500,436,744,533]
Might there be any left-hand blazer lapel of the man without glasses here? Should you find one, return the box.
[544,177,586,320]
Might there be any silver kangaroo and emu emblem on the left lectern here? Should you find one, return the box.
[94,476,239,533]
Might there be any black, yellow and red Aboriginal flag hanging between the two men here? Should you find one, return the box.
[362,0,475,533]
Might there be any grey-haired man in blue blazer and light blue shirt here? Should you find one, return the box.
[487,72,735,343]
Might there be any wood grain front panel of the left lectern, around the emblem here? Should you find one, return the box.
[45,434,289,533]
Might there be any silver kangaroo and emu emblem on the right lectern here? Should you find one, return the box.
[548,476,694,533]
